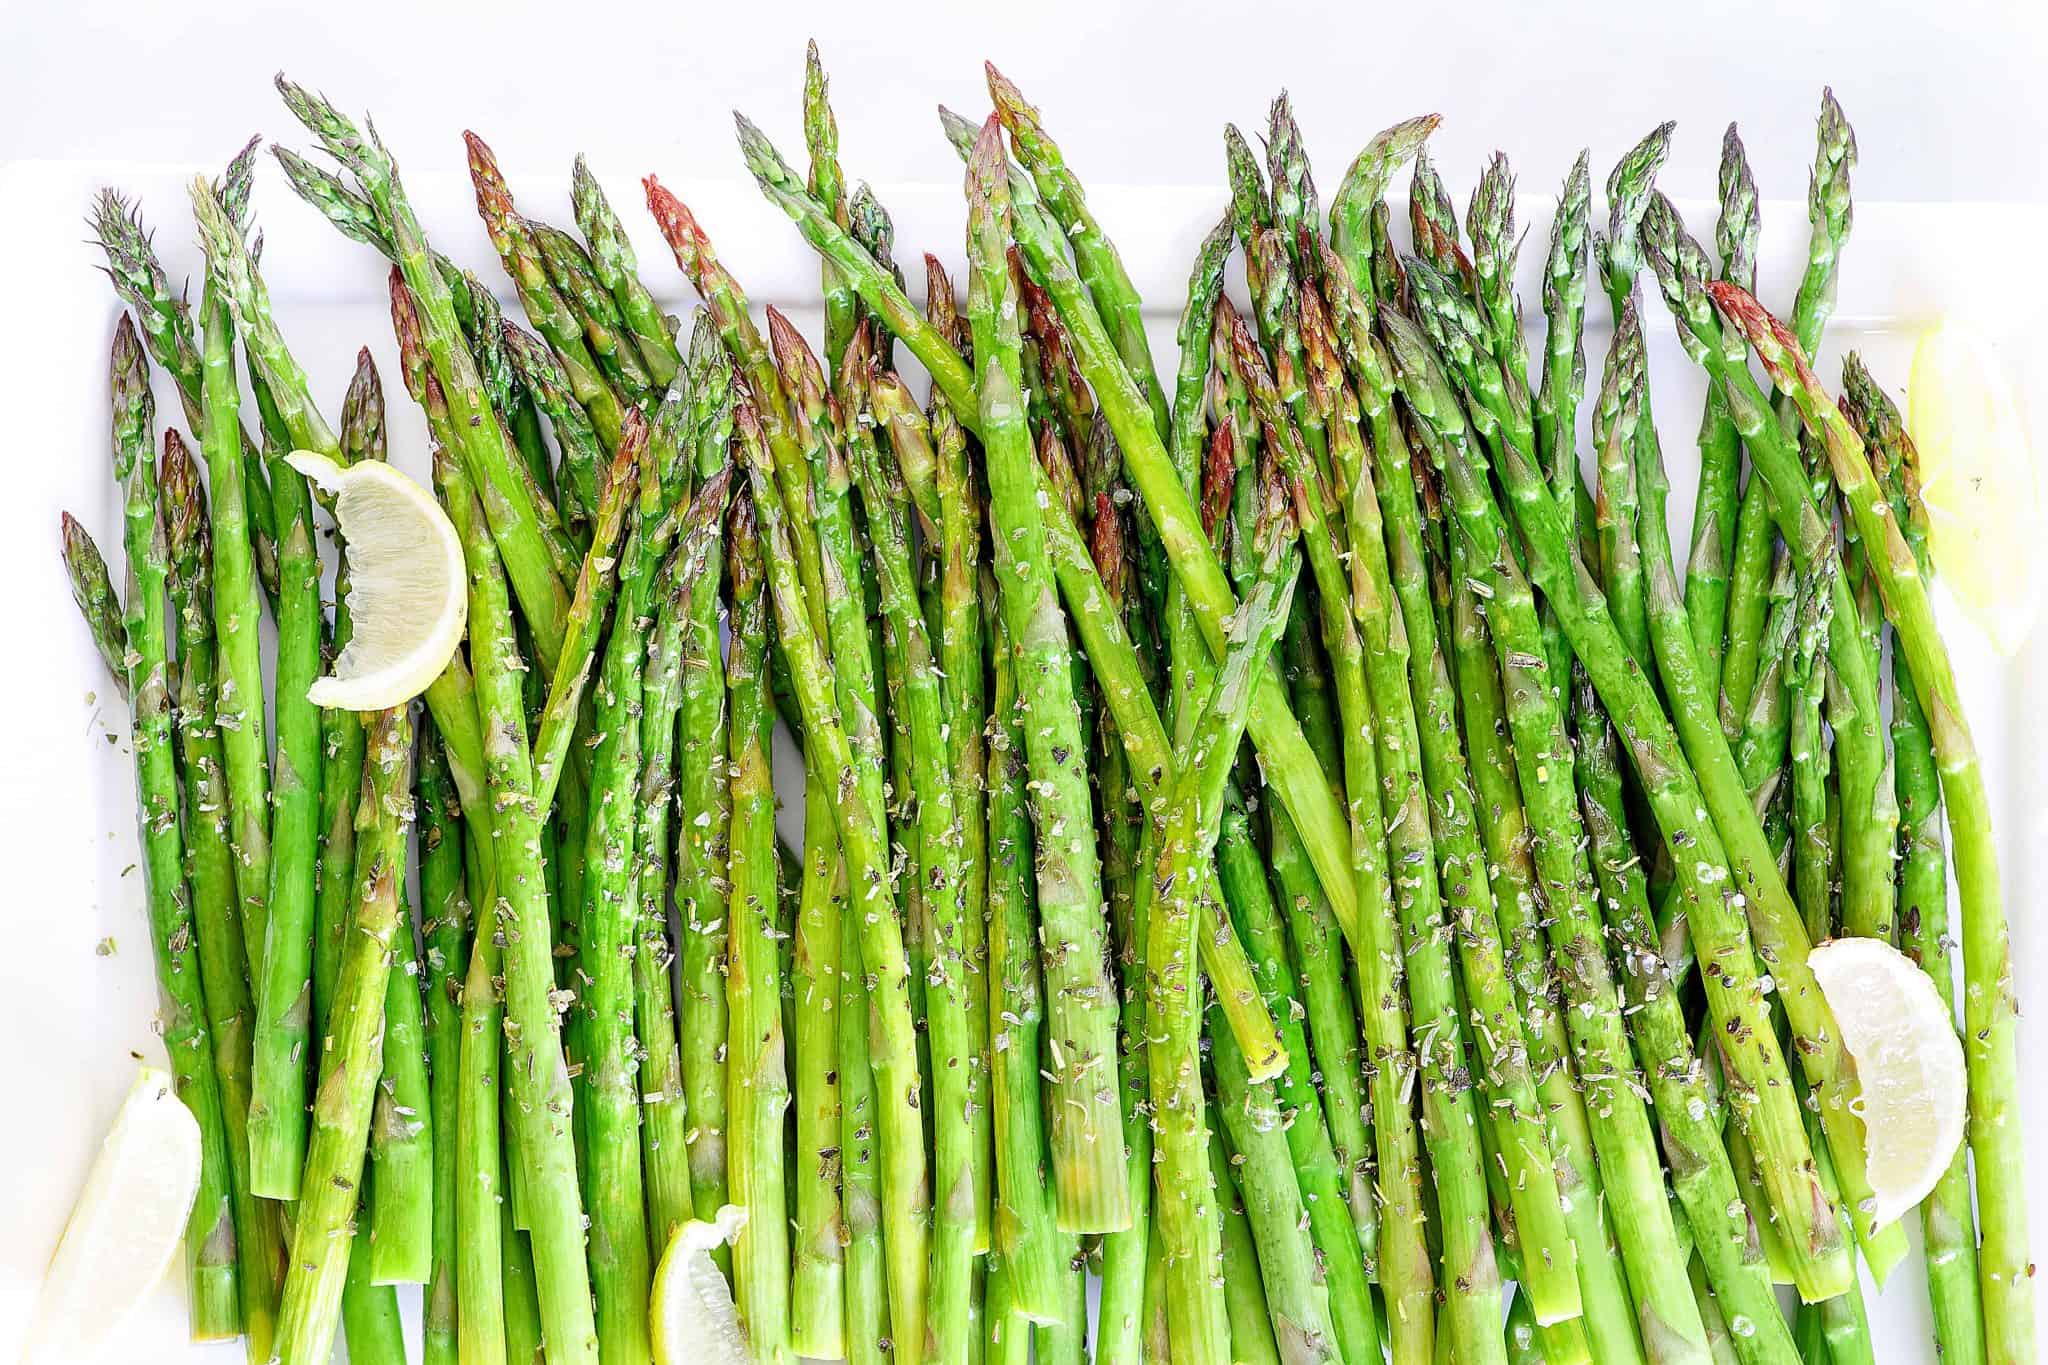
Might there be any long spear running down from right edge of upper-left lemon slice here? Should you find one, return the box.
[434,450,598,1363]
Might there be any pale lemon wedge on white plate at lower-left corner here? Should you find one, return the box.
[23,1066,199,1365]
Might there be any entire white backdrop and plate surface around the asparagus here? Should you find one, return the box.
[0,0,2048,1363]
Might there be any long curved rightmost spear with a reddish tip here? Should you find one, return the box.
[1710,284,2034,1359]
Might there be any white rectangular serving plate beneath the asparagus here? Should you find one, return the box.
[0,144,2048,1365]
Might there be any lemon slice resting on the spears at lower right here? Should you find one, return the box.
[1806,939,1968,1228]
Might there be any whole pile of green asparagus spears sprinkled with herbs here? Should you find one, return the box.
[63,47,2034,1365]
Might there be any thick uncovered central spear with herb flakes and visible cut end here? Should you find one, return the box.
[967,119,1130,1232]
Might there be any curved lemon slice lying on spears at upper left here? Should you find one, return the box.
[285,450,469,710]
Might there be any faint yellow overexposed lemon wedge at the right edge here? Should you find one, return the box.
[1907,319,2042,655]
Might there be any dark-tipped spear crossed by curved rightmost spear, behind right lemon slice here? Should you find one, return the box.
[1841,352,1985,1365]
